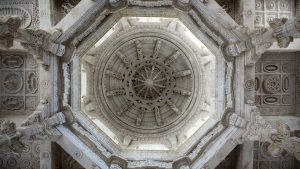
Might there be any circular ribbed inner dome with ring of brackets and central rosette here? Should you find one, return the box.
[95,32,195,134]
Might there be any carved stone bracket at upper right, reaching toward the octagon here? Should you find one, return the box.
[221,16,300,63]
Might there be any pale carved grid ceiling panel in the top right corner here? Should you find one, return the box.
[255,0,295,27]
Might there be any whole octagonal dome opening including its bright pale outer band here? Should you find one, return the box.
[77,17,221,160]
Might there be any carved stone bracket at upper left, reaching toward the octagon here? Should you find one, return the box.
[0,16,66,66]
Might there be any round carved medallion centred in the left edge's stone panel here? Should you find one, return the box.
[3,72,23,93]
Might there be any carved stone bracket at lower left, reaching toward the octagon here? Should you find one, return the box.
[0,100,75,153]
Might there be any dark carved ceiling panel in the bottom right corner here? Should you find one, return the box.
[253,141,296,169]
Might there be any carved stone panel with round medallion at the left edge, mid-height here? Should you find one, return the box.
[0,51,39,115]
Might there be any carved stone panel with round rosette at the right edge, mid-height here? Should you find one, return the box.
[255,53,297,115]
